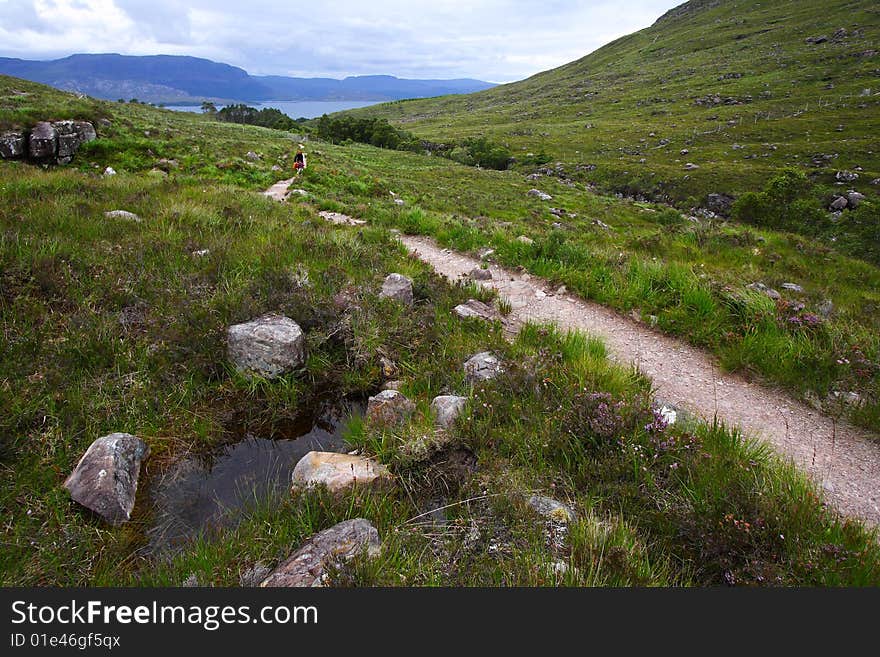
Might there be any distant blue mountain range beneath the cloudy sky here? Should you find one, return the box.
[0,54,495,104]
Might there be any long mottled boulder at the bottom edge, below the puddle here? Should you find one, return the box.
[260,518,381,588]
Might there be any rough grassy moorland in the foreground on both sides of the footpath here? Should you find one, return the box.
[0,78,880,586]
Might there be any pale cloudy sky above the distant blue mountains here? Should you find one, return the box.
[0,0,684,82]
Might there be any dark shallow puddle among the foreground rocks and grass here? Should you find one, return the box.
[147,402,364,553]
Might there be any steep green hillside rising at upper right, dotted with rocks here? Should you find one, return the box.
[344,0,880,205]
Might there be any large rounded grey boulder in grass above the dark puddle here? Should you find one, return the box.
[227,314,306,379]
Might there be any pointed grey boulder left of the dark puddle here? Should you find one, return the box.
[64,433,150,525]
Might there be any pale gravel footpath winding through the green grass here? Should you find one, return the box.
[266,181,880,526]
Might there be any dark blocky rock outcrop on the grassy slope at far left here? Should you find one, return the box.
[0,120,98,164]
